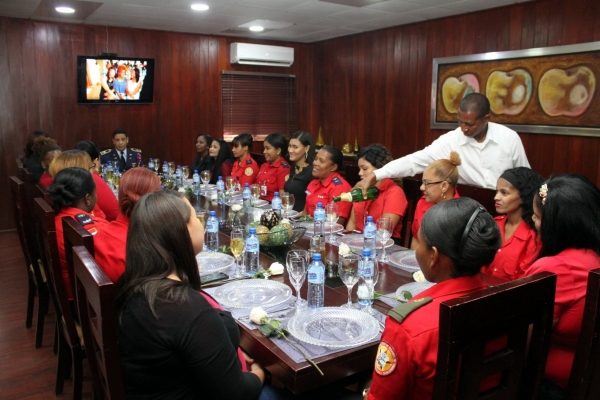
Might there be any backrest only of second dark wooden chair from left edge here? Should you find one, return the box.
[34,197,79,343]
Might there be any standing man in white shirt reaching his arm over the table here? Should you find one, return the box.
[355,93,529,190]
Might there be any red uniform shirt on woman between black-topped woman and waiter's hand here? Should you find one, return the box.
[304,172,352,218]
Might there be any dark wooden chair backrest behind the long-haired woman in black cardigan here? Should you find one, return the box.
[72,246,125,400]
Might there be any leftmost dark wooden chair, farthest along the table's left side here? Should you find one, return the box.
[9,176,50,349]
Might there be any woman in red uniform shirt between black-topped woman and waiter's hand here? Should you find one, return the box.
[303,146,352,225]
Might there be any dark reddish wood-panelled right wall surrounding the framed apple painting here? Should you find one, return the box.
[314,0,600,185]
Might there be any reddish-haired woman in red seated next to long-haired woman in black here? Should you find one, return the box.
[94,168,161,282]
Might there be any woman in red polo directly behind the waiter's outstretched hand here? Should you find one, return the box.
[346,144,408,239]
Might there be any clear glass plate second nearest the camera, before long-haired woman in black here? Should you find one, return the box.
[214,279,292,308]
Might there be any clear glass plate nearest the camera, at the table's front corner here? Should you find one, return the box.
[287,307,379,348]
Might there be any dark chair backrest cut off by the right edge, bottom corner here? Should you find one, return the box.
[566,269,600,400]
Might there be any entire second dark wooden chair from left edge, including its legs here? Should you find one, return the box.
[34,197,83,400]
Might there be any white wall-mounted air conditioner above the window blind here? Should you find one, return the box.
[229,43,294,67]
